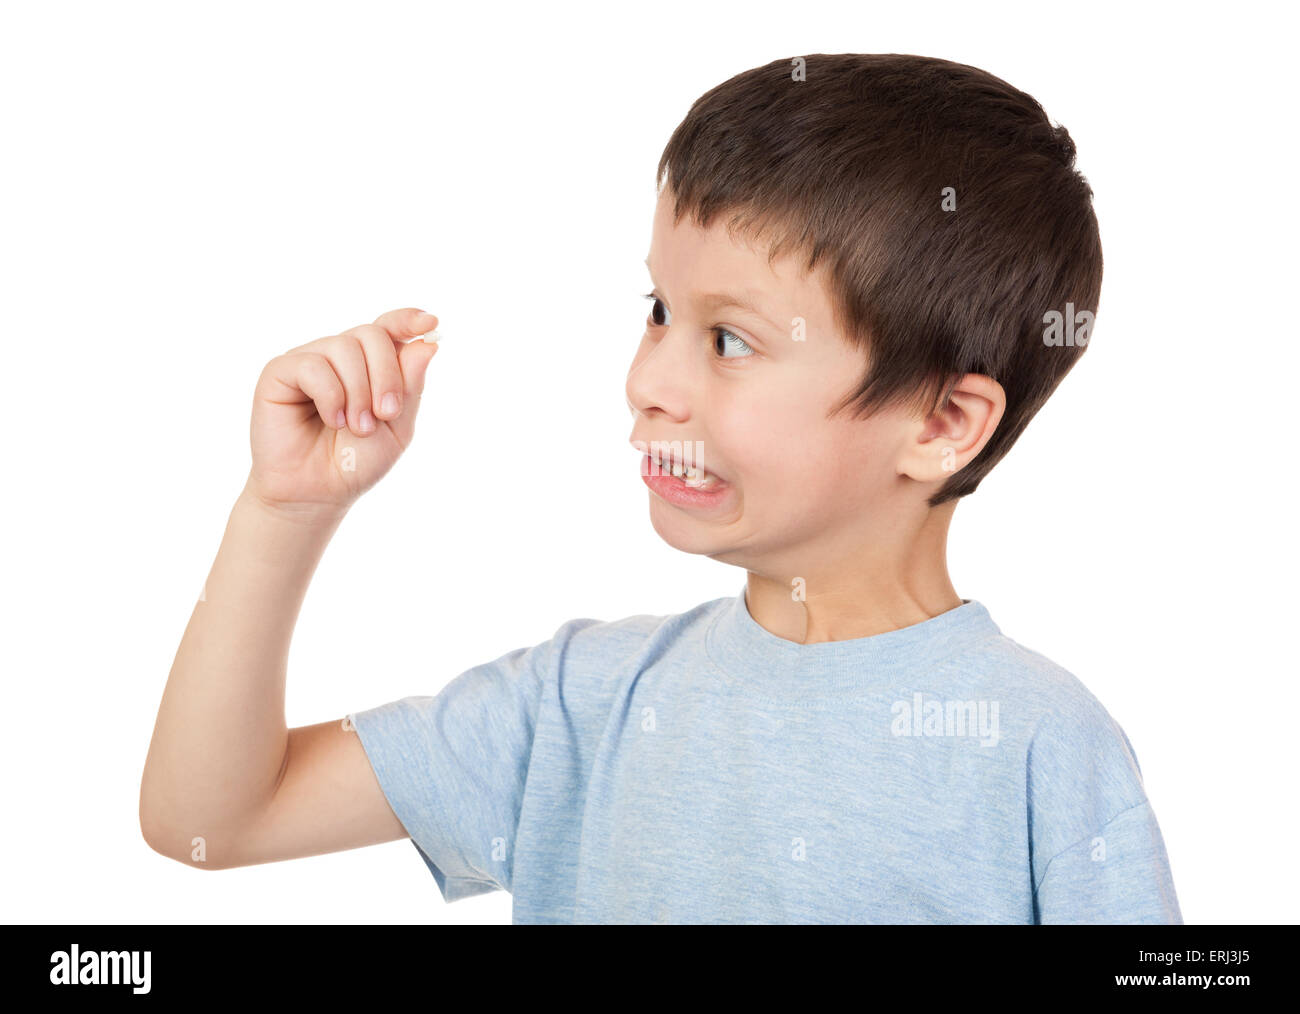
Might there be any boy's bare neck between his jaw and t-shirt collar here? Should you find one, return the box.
[745,501,962,645]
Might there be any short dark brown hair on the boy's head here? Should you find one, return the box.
[655,53,1101,504]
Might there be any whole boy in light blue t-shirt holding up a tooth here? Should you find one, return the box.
[140,55,1182,923]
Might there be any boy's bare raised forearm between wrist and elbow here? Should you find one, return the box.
[140,478,343,854]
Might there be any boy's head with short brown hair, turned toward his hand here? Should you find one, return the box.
[627,53,1101,555]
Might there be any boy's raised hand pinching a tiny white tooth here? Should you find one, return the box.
[246,307,438,519]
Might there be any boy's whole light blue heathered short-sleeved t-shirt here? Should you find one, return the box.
[350,589,1182,923]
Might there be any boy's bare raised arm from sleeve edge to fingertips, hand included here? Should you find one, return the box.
[139,308,437,870]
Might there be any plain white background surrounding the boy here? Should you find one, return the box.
[0,0,1300,920]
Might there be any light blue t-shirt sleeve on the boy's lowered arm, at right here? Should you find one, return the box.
[1028,701,1183,924]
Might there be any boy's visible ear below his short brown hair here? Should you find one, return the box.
[898,373,1006,484]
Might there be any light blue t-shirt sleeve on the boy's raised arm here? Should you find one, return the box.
[348,624,567,902]
